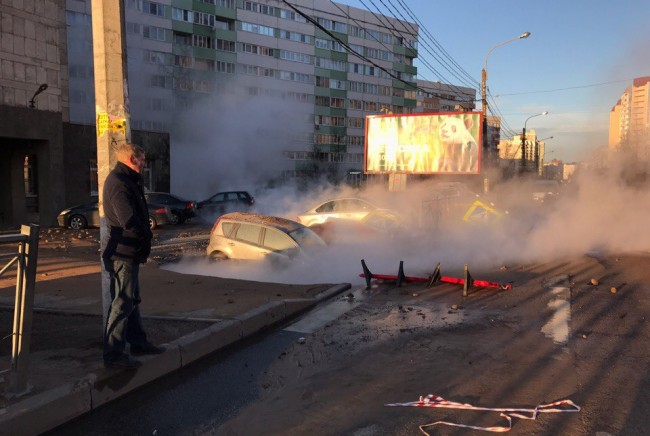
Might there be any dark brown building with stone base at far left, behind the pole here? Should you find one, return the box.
[0,0,169,228]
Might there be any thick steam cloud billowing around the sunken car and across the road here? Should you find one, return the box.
[166,76,650,284]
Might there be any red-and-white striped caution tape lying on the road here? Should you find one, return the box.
[384,394,581,436]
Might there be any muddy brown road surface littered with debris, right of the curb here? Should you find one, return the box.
[219,256,650,436]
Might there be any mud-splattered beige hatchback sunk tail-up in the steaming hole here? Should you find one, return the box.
[206,212,326,265]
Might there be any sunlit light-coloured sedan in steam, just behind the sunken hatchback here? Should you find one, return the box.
[296,198,399,227]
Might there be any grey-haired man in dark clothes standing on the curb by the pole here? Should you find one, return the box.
[102,143,164,369]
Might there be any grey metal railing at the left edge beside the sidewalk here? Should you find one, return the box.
[0,224,39,396]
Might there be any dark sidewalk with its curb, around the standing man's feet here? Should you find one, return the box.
[0,229,350,435]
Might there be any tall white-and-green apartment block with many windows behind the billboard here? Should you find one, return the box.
[68,0,418,192]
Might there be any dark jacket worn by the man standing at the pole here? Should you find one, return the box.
[102,162,153,263]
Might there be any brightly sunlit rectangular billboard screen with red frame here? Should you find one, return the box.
[364,112,481,174]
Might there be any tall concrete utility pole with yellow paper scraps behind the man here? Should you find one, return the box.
[91,0,131,329]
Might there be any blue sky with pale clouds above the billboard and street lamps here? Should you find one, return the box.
[338,0,650,162]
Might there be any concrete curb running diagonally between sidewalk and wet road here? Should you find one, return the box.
[0,283,351,436]
